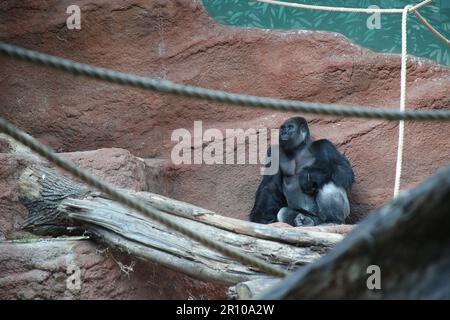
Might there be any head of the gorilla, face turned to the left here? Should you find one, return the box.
[279,117,310,151]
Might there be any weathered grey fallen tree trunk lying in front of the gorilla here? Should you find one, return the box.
[20,164,343,284]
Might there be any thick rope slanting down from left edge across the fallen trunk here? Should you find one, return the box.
[0,117,288,277]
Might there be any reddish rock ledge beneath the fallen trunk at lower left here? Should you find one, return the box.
[0,240,226,300]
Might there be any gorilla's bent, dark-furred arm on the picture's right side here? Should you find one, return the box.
[311,139,355,192]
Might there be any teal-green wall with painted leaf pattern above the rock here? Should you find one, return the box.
[203,0,450,66]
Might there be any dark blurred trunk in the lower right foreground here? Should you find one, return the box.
[259,166,450,299]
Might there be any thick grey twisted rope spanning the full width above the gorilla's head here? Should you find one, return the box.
[0,42,450,121]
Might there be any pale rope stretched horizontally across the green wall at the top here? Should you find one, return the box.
[256,0,433,13]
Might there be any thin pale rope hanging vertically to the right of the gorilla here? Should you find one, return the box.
[394,5,411,197]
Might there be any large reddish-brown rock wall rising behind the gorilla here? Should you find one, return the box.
[0,0,450,300]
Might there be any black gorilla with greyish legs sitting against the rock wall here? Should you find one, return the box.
[250,117,354,226]
